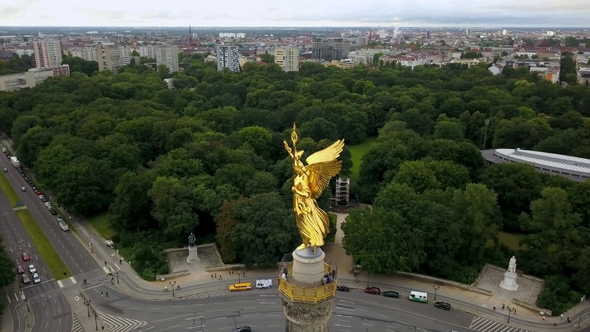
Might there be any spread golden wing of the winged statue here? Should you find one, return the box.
[305,140,344,199]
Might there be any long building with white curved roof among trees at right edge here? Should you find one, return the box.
[482,148,590,181]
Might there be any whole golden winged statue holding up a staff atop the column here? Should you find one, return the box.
[283,124,344,252]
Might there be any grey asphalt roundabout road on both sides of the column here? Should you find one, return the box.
[78,284,473,332]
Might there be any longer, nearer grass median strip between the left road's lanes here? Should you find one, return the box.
[15,209,72,280]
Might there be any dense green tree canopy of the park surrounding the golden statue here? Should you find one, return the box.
[0,55,590,312]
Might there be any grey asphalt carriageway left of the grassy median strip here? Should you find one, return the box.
[0,172,72,332]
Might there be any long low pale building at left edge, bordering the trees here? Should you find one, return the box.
[0,65,70,91]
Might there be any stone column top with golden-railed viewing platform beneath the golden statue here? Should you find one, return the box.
[279,248,336,332]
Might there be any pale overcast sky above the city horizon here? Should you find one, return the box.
[0,0,590,27]
